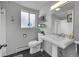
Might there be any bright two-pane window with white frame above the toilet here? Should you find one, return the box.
[21,11,35,28]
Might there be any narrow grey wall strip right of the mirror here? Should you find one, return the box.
[73,1,79,40]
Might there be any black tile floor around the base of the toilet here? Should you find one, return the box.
[5,49,51,57]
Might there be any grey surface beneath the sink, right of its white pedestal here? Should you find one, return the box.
[58,43,76,57]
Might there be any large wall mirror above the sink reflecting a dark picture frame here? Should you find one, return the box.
[51,2,74,38]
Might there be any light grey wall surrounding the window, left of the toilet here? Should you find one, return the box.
[1,2,38,55]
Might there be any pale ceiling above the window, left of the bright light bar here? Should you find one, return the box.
[13,1,56,10]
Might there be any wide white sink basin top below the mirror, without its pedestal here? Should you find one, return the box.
[38,34,74,49]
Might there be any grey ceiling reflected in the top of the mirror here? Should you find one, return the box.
[53,2,74,19]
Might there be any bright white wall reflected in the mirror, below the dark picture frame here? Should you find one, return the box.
[57,19,73,34]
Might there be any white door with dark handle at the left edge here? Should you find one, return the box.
[0,8,6,57]
